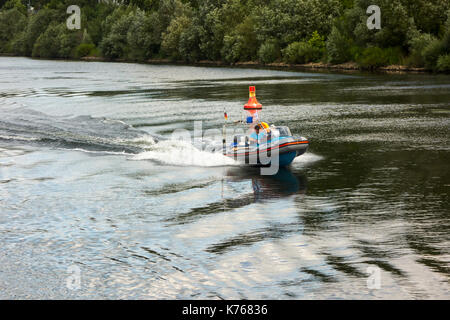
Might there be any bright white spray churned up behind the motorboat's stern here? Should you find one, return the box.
[132,140,238,167]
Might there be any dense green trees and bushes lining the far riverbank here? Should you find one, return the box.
[0,0,450,72]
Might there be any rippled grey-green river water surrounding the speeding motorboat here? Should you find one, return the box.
[0,57,450,299]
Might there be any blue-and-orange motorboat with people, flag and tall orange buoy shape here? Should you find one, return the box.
[223,86,309,167]
